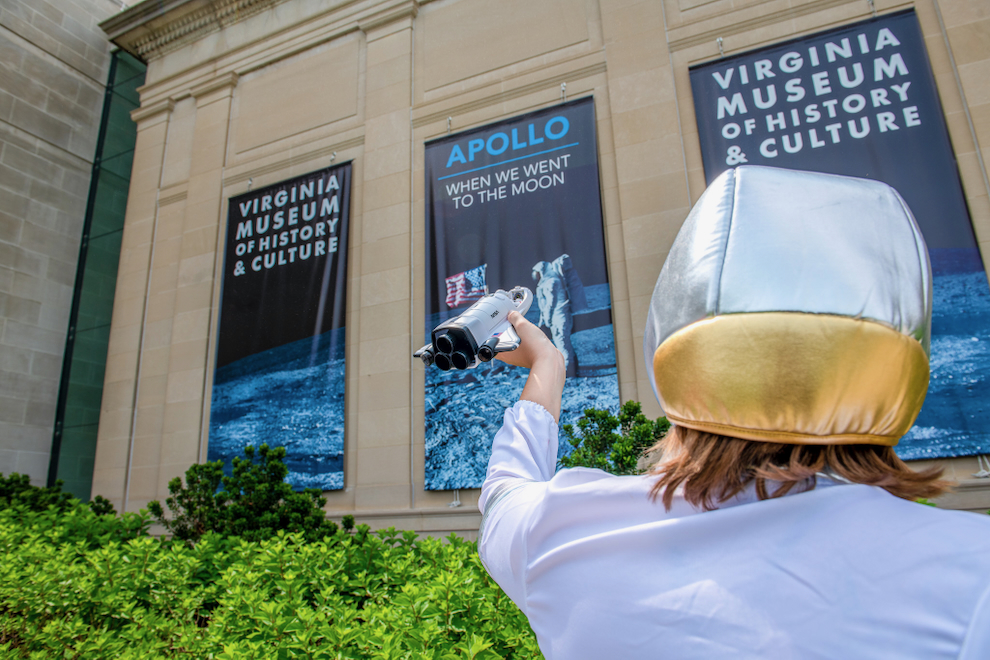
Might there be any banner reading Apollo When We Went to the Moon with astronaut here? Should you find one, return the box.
[424,98,619,490]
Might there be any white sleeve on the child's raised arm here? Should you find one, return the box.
[478,401,557,612]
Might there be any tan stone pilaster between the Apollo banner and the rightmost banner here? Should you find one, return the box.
[601,0,700,416]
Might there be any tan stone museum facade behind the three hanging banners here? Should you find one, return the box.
[99,0,990,534]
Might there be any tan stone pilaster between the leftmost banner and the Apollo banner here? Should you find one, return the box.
[348,2,422,510]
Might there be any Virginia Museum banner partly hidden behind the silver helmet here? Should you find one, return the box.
[691,10,990,459]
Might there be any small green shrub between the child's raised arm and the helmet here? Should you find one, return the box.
[560,401,670,475]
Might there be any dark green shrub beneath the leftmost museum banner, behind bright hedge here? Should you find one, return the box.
[148,444,337,545]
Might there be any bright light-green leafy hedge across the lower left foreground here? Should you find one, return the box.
[0,509,541,660]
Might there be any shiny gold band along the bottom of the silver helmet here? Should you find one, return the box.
[653,312,929,446]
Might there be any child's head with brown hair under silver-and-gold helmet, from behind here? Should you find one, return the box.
[644,166,937,505]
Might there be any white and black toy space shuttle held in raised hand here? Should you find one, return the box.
[413,286,533,371]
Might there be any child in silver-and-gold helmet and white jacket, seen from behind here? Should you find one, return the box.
[479,167,990,660]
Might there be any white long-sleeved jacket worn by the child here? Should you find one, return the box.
[478,401,990,660]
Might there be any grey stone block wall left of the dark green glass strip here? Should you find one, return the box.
[0,0,121,485]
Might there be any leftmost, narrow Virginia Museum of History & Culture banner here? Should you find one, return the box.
[209,163,351,490]
